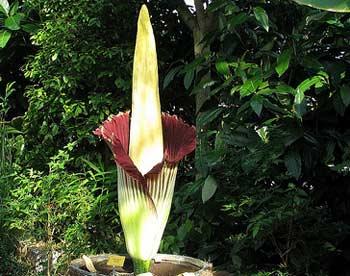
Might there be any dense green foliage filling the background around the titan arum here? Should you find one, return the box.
[0,0,350,275]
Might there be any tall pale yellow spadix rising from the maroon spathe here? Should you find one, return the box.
[129,5,163,175]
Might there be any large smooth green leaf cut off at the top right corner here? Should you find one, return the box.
[293,0,350,12]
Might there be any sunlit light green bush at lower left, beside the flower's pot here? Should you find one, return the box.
[2,144,122,271]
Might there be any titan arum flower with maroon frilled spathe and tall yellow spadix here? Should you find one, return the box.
[94,5,196,274]
